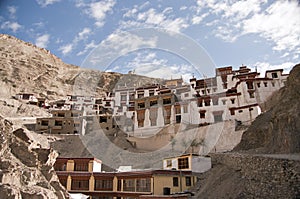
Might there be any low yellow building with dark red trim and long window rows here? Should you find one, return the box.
[54,158,196,199]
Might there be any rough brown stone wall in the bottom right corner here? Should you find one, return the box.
[211,153,300,198]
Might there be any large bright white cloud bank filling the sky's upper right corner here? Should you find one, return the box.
[197,0,300,54]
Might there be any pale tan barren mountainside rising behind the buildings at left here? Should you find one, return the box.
[0,34,159,99]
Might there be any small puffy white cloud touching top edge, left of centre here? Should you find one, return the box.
[89,0,116,27]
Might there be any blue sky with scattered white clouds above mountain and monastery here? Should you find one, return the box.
[0,0,300,80]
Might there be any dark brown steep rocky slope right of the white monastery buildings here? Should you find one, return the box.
[235,64,300,153]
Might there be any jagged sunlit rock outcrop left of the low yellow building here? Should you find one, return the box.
[0,116,69,199]
